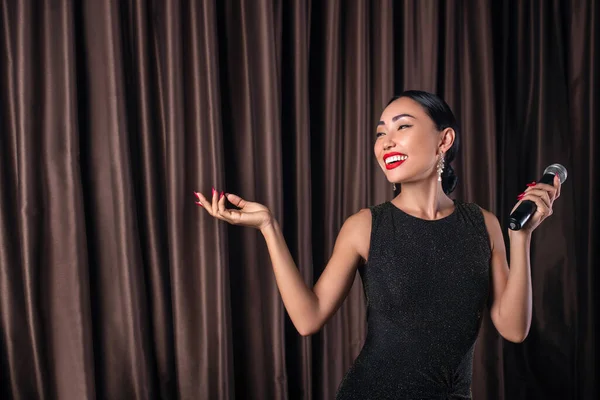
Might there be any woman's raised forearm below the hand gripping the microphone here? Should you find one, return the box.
[498,231,532,342]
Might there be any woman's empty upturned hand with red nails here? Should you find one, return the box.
[194,188,272,230]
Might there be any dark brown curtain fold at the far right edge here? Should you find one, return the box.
[561,2,600,398]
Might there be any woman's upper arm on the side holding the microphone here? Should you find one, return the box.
[482,209,509,326]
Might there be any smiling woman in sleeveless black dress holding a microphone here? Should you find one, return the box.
[196,91,560,400]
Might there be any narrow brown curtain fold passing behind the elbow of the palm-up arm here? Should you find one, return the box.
[280,0,314,399]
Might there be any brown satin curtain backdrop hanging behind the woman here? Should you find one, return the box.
[0,0,600,400]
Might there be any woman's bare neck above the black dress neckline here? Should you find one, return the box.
[392,176,454,220]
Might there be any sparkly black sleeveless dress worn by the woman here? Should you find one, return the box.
[336,200,491,400]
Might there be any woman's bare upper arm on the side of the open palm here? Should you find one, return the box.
[313,209,371,325]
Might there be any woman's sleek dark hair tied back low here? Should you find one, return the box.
[386,90,460,194]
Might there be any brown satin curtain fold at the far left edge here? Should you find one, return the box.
[0,2,49,396]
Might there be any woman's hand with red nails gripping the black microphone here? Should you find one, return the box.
[511,176,560,233]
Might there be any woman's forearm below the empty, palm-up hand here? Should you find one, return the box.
[261,220,319,335]
